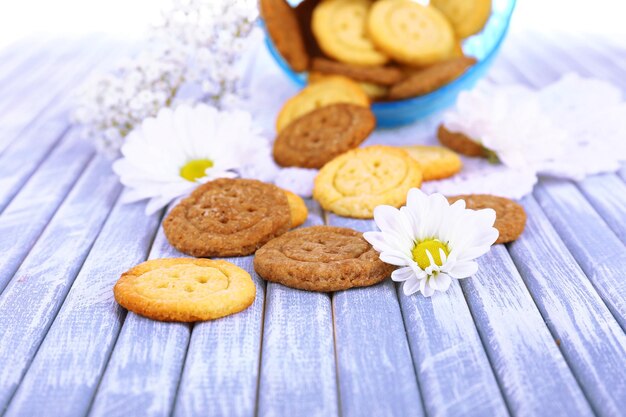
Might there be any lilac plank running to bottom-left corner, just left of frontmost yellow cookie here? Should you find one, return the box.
[5,192,160,417]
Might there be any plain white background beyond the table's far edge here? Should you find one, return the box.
[0,0,626,47]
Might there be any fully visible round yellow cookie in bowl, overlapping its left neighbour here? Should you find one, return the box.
[367,0,455,66]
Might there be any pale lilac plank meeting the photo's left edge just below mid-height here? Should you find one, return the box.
[0,130,94,291]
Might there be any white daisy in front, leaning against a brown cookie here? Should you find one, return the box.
[364,188,498,297]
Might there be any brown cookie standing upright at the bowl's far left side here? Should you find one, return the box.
[260,0,309,72]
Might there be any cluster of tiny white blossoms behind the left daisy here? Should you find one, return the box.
[73,0,258,156]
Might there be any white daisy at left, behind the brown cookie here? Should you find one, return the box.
[113,104,275,214]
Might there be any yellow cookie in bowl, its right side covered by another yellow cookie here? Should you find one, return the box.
[311,0,389,66]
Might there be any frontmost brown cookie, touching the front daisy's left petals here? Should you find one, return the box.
[254,226,395,291]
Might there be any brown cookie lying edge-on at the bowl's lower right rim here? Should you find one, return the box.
[389,56,476,100]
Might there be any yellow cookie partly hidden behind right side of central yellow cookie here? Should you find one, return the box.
[401,145,463,181]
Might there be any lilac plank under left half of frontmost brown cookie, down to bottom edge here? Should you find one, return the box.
[250,200,338,416]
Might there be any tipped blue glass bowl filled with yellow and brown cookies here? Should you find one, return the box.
[260,0,502,127]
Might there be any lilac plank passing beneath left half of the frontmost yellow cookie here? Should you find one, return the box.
[89,228,191,417]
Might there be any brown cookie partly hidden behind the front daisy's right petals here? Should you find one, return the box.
[448,194,526,243]
